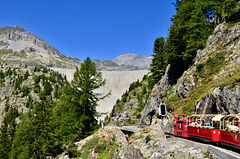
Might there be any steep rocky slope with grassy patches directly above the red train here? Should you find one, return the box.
[141,23,240,124]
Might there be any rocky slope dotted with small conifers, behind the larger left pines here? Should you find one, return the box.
[0,63,67,124]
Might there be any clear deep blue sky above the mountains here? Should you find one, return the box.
[0,0,176,60]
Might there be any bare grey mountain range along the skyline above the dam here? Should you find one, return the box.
[0,26,152,71]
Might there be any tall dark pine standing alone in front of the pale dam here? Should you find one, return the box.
[71,57,107,135]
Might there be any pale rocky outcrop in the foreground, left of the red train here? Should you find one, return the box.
[114,120,206,159]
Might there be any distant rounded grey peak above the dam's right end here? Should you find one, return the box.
[113,53,153,70]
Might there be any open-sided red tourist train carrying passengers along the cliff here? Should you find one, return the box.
[174,114,240,149]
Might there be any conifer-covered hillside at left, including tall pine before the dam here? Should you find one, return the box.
[0,58,106,158]
